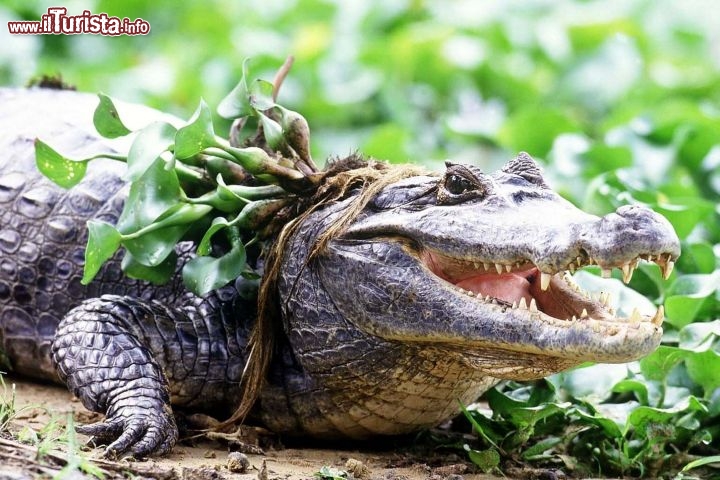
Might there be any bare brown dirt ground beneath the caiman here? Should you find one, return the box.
[0,377,500,480]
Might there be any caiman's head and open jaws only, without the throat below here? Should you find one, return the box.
[321,153,680,372]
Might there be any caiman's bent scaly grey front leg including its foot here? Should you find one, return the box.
[52,295,248,457]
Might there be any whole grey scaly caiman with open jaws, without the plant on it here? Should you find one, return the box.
[0,89,680,456]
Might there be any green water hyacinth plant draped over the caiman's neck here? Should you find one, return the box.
[35,61,322,295]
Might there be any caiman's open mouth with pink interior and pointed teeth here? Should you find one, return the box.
[422,251,674,326]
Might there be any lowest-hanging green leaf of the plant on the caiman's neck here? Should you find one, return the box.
[183,242,246,296]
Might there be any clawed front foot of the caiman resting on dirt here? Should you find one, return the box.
[76,405,178,458]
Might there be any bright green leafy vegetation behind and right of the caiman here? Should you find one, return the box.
[0,0,720,478]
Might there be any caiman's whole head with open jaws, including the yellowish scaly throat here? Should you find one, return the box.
[272,154,680,436]
